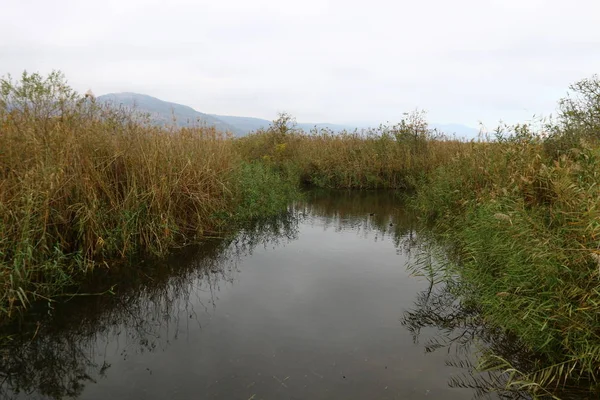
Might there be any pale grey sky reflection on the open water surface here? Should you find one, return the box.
[82,218,482,399]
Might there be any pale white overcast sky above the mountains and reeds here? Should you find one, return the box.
[0,0,600,127]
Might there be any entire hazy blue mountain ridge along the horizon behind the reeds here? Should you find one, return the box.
[97,92,478,139]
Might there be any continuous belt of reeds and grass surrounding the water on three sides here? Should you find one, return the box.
[0,69,600,396]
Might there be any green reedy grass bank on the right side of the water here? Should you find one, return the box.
[414,80,600,398]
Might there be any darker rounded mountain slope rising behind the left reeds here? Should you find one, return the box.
[97,93,244,136]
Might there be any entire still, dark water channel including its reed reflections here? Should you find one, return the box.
[0,193,506,400]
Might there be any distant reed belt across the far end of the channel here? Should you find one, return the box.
[237,113,466,189]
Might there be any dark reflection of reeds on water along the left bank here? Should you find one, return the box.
[0,212,298,399]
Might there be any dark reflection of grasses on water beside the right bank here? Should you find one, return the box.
[402,262,570,399]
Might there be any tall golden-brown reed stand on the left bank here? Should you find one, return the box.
[0,73,300,318]
